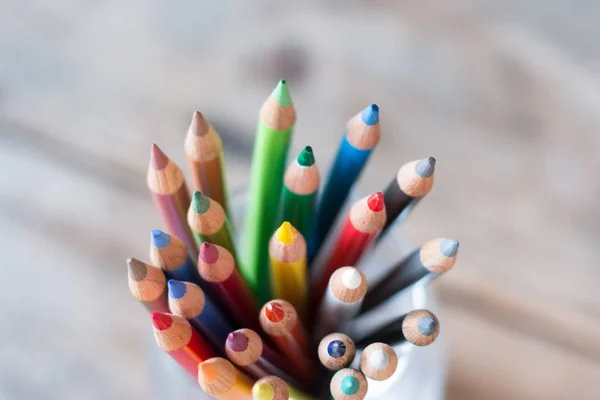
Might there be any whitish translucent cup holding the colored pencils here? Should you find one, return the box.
[148,189,447,400]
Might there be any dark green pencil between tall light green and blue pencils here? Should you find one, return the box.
[283,146,320,238]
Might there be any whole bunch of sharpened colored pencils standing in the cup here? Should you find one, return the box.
[128,80,458,400]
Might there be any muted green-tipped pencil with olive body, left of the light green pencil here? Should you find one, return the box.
[188,192,235,255]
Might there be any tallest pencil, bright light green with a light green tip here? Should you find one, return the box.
[240,80,296,304]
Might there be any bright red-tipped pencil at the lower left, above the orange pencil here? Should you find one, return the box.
[152,311,217,378]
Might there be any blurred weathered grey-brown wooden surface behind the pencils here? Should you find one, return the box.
[0,0,600,400]
